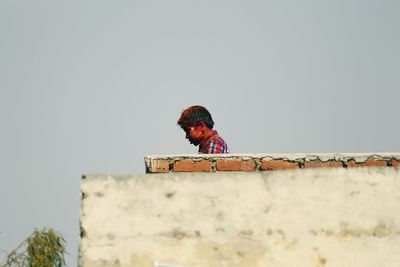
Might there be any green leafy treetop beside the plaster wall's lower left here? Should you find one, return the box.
[0,229,66,267]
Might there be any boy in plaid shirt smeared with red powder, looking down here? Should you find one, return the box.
[178,106,229,154]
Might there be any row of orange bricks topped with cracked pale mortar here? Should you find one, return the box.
[144,152,400,173]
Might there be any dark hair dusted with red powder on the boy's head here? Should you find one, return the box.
[178,106,214,130]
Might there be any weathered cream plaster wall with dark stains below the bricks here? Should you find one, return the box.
[80,167,400,267]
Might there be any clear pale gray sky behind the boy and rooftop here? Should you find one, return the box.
[0,0,400,266]
